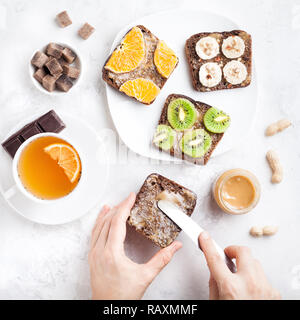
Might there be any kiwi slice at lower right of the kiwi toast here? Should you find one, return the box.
[179,129,211,158]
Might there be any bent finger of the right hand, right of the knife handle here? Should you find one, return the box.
[225,246,256,271]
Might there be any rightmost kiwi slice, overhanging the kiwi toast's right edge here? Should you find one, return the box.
[203,108,230,133]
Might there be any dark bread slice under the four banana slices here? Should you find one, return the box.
[185,30,252,92]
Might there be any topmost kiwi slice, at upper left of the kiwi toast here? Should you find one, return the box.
[168,98,197,131]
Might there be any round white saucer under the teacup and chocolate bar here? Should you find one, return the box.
[0,110,109,225]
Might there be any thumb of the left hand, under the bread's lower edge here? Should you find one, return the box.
[145,241,182,282]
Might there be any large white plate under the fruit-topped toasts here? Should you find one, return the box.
[106,10,257,161]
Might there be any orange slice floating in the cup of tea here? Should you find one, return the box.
[44,143,81,183]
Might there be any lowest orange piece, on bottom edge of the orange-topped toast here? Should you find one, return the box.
[120,78,160,104]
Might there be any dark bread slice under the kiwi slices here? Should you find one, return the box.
[154,94,224,165]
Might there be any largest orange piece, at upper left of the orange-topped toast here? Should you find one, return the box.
[105,27,145,73]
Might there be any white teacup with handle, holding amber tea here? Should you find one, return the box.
[5,132,84,204]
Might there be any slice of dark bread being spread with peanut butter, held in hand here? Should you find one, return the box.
[127,173,197,248]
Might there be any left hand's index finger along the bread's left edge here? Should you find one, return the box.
[107,193,135,250]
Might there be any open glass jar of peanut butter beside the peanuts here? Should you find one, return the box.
[213,169,260,214]
